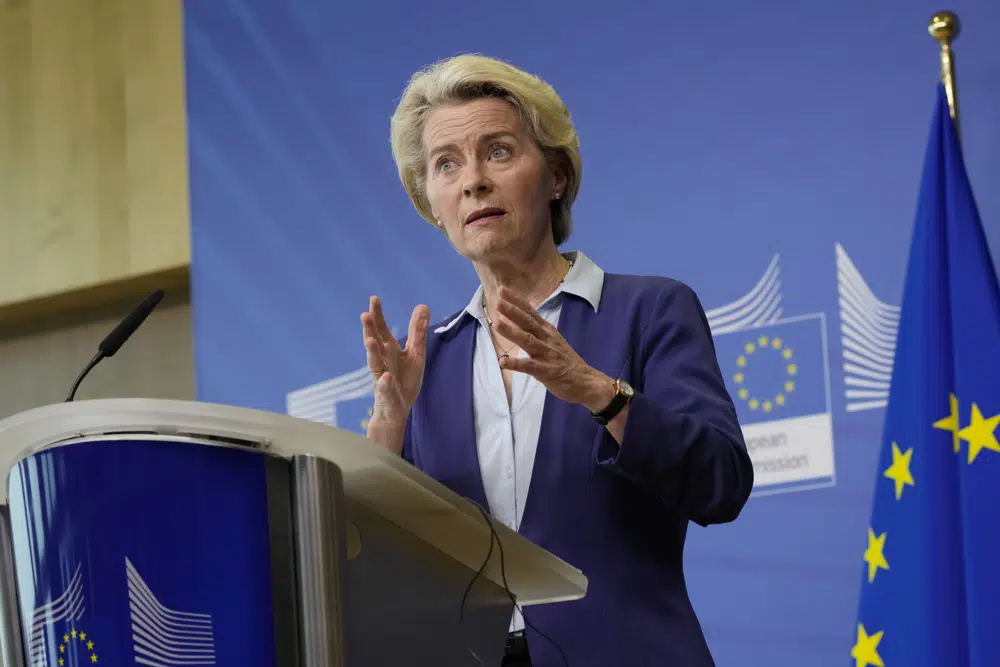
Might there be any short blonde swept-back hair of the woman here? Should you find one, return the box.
[391,54,582,246]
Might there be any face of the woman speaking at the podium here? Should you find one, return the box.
[424,98,565,261]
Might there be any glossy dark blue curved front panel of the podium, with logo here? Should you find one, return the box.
[8,438,287,667]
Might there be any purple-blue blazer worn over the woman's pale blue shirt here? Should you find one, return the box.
[403,273,753,667]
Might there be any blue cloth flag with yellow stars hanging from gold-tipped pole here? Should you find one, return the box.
[851,86,1000,667]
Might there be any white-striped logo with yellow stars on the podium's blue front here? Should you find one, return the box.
[28,558,216,667]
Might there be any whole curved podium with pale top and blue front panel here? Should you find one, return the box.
[0,399,587,667]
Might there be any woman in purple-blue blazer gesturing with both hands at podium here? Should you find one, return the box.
[361,55,753,667]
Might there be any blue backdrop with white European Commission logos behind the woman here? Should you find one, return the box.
[185,0,1000,667]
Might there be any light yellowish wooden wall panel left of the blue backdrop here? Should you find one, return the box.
[0,0,190,320]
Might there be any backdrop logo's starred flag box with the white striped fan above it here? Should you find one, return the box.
[706,255,836,495]
